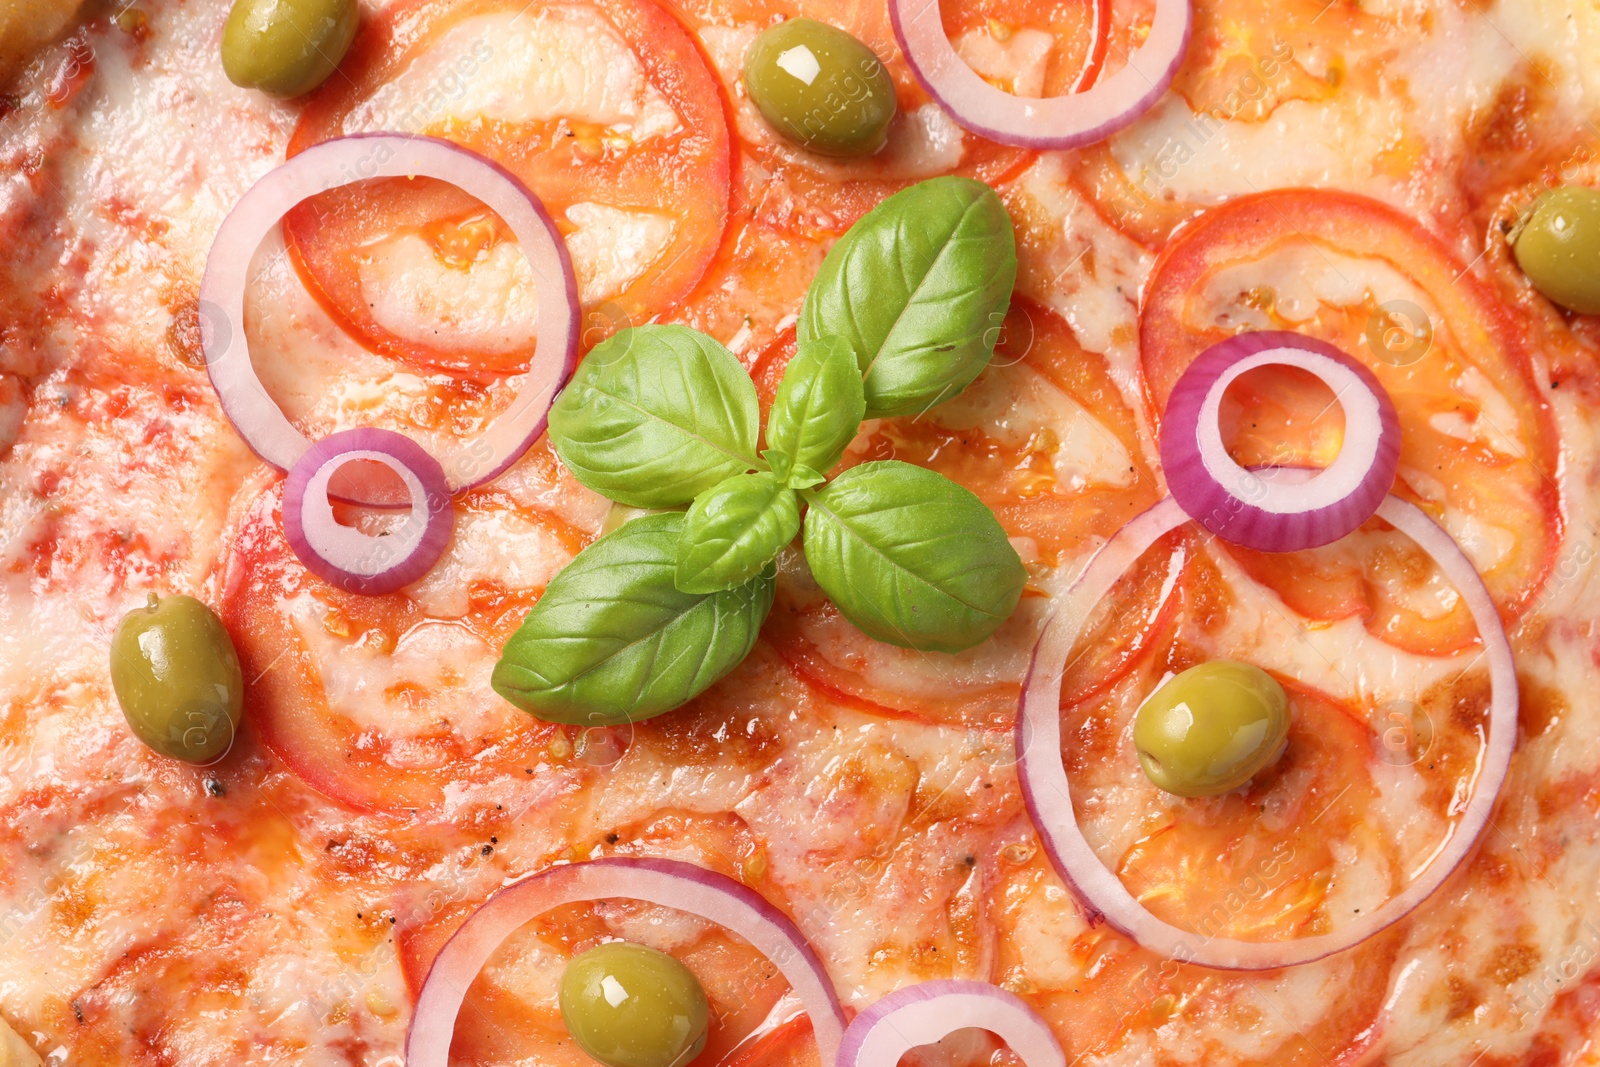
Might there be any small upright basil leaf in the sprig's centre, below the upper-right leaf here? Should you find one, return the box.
[766,338,867,485]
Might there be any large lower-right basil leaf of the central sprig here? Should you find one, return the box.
[805,459,1027,653]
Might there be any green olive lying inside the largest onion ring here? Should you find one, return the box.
[1133,659,1290,797]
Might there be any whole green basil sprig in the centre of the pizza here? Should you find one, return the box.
[493,178,1027,725]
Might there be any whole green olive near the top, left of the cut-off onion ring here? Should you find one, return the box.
[744,19,894,157]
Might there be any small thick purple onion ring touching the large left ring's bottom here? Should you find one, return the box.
[283,427,456,597]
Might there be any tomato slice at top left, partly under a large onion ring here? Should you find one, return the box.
[283,0,730,373]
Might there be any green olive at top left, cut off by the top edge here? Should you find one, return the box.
[222,0,360,96]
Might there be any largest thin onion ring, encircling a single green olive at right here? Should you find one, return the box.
[1016,496,1517,971]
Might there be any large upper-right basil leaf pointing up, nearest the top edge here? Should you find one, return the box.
[797,178,1016,418]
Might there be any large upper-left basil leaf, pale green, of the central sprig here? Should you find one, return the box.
[550,326,760,507]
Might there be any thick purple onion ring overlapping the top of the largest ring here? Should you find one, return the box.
[1162,331,1400,552]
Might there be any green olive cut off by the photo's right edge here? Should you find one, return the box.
[1512,186,1600,315]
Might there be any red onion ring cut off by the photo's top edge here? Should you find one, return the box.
[890,0,1194,149]
